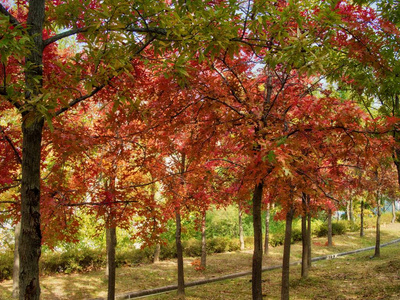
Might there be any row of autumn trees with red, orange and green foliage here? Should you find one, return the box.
[0,0,400,299]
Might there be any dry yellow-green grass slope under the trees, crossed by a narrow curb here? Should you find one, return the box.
[0,223,400,300]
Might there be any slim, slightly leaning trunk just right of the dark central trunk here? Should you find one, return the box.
[281,207,294,300]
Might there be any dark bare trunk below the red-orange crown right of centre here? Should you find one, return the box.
[251,182,264,300]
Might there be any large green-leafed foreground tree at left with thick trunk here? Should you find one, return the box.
[0,0,245,299]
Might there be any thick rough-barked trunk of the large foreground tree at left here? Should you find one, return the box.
[19,0,45,300]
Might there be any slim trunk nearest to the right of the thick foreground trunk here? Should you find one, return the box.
[106,227,117,300]
